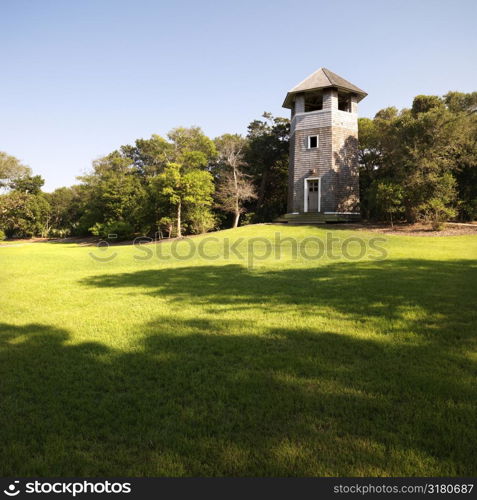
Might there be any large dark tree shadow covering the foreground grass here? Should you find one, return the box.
[0,318,475,476]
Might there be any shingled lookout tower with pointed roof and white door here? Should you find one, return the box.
[281,68,367,222]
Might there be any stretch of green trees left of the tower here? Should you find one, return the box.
[0,113,290,239]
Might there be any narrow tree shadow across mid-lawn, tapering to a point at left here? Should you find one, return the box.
[82,259,477,343]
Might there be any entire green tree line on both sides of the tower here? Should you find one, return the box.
[0,92,477,239]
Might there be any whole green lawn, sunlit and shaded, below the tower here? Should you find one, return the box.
[0,226,477,476]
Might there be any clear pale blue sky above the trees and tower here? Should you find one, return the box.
[0,0,477,190]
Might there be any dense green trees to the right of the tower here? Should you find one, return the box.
[359,93,470,225]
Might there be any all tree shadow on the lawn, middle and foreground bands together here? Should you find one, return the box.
[0,261,477,476]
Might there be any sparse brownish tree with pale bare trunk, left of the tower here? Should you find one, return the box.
[215,134,257,228]
